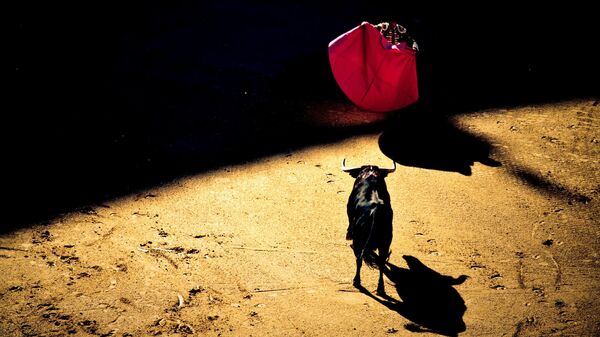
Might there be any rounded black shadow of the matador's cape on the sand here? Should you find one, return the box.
[379,104,501,176]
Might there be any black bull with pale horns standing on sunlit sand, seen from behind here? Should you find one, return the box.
[342,160,396,294]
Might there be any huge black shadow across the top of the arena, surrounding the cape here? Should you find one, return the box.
[10,1,598,231]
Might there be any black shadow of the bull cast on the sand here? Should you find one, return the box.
[360,255,467,336]
